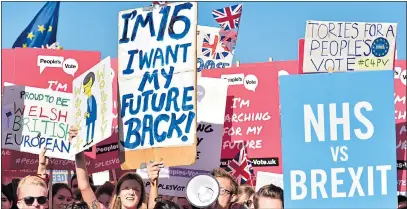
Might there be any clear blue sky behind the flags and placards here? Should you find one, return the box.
[1,2,406,63]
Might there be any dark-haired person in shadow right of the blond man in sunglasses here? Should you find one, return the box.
[51,183,73,209]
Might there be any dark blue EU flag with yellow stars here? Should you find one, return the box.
[13,1,59,48]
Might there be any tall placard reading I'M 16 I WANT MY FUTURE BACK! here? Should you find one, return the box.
[118,2,197,169]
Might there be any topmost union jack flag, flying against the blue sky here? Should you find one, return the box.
[212,4,243,30]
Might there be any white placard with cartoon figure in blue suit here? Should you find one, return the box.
[72,57,113,153]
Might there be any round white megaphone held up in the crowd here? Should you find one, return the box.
[187,174,220,208]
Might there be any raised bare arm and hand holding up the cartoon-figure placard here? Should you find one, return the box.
[69,126,104,209]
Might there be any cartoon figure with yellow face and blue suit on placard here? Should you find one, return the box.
[83,72,97,147]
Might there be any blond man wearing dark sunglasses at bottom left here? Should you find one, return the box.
[17,176,48,209]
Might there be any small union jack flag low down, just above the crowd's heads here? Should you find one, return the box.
[225,146,254,185]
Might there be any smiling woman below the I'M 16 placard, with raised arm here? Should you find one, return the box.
[69,126,158,209]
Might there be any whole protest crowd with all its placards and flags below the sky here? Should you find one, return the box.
[1,2,407,209]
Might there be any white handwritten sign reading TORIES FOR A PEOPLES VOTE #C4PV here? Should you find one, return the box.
[303,21,397,73]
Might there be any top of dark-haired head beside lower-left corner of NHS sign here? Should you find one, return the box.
[253,184,284,209]
